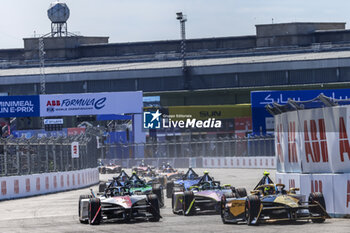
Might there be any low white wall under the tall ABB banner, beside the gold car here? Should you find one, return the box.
[276,172,350,217]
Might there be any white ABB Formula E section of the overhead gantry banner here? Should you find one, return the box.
[40,92,142,117]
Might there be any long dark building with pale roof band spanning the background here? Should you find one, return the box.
[0,22,350,133]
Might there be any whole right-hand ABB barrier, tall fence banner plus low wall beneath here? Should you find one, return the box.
[275,105,350,217]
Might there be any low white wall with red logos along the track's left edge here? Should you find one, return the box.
[0,168,99,200]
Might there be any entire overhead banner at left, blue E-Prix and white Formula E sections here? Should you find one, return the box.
[0,91,143,118]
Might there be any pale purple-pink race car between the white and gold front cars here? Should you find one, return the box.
[172,172,247,216]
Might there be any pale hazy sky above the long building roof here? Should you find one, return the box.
[0,0,350,49]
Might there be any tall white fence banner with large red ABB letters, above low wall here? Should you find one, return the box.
[275,106,350,173]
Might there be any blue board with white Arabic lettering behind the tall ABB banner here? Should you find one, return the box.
[251,89,350,135]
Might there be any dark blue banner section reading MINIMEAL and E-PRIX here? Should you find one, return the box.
[0,95,40,117]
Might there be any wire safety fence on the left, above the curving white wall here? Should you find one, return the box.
[0,134,98,176]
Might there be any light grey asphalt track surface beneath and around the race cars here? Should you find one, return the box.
[0,169,350,233]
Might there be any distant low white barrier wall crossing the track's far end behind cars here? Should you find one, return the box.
[104,156,276,169]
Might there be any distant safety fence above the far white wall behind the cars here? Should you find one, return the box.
[101,136,275,159]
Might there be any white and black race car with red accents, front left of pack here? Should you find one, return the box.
[79,186,161,225]
